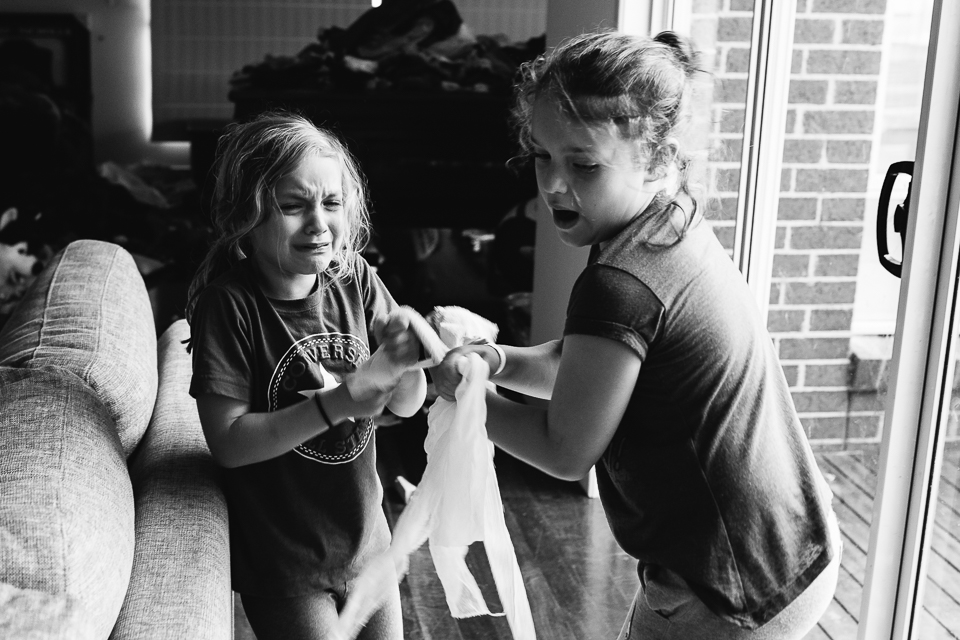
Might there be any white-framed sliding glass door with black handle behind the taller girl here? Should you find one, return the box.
[632,0,960,640]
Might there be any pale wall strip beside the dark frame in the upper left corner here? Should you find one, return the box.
[3,0,189,165]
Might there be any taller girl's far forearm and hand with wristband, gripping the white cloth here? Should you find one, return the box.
[430,340,563,400]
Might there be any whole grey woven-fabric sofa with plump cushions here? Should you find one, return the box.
[0,240,233,640]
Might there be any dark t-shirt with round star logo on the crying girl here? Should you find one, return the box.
[190,260,396,596]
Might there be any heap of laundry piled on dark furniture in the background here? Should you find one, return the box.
[223,0,546,101]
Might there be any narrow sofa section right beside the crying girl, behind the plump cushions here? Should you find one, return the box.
[111,320,233,640]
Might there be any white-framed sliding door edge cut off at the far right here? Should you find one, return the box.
[880,0,960,640]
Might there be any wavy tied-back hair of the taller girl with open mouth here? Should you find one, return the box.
[512,31,706,242]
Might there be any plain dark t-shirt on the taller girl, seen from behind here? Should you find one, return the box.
[564,212,832,627]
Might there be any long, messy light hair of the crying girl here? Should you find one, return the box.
[186,111,370,322]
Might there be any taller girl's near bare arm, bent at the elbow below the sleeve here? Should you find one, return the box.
[487,335,641,480]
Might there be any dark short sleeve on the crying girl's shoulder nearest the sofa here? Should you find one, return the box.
[190,287,253,402]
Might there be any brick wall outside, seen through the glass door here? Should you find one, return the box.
[692,0,887,446]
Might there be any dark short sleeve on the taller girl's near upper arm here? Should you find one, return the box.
[563,264,664,359]
